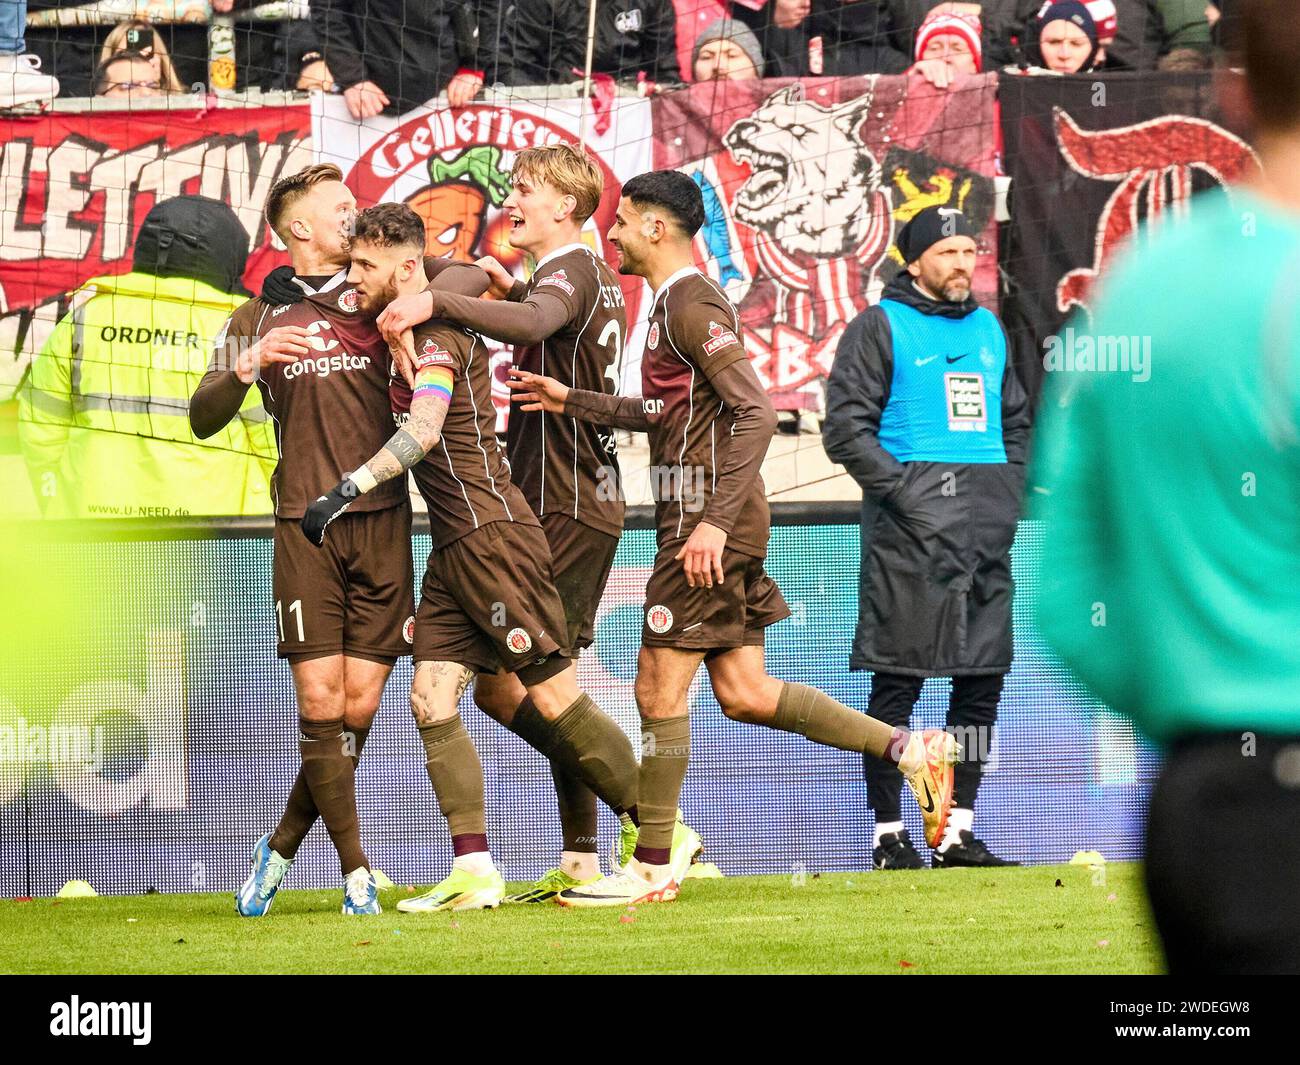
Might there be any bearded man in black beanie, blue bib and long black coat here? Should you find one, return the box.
[823,207,1028,869]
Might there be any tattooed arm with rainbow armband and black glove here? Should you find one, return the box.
[302,364,455,547]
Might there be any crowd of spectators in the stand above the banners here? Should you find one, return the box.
[0,0,1232,111]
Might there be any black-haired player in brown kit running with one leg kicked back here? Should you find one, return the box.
[511,170,956,906]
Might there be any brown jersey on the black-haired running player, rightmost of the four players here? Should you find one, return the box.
[641,268,771,558]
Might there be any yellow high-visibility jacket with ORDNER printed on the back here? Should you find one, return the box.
[18,266,276,518]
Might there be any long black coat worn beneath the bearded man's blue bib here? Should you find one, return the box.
[822,272,1030,676]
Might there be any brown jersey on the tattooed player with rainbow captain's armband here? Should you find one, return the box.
[395,320,538,550]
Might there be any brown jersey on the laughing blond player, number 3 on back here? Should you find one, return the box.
[506,244,628,536]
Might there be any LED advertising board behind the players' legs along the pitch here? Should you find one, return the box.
[0,516,1157,896]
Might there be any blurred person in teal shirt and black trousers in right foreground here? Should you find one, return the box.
[1031,0,1300,974]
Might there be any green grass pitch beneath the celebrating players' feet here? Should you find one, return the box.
[0,863,1161,974]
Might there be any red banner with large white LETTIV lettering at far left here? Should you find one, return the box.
[0,104,312,401]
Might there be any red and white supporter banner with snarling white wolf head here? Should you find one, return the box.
[654,75,997,410]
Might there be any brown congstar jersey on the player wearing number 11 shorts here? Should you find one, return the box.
[209,270,406,518]
